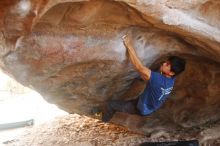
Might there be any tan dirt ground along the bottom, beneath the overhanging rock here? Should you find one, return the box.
[3,114,220,146]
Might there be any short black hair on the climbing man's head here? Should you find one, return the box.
[168,56,186,76]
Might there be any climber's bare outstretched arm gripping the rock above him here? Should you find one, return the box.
[123,35,151,81]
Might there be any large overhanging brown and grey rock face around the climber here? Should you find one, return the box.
[0,0,220,144]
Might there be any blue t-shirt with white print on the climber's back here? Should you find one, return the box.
[137,71,175,115]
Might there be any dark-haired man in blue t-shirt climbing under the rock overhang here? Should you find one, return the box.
[102,34,185,122]
